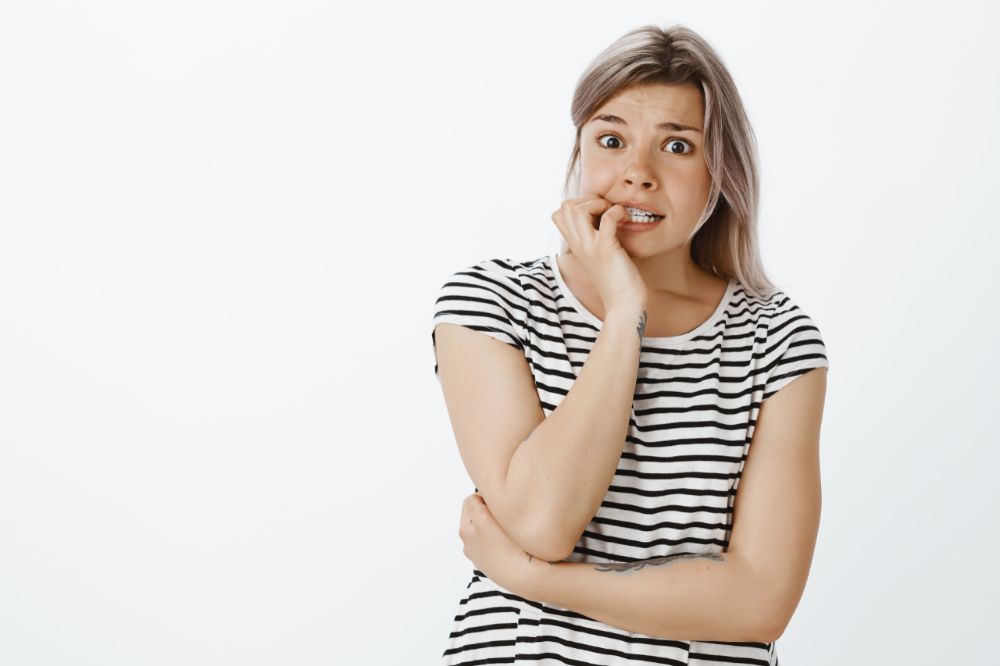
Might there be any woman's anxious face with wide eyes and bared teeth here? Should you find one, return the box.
[580,84,711,257]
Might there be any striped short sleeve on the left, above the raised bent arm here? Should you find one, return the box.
[431,259,526,375]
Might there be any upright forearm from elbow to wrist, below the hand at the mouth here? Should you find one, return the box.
[504,304,645,559]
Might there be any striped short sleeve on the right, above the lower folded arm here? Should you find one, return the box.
[761,293,830,402]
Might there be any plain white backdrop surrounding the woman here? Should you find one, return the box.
[0,0,1000,666]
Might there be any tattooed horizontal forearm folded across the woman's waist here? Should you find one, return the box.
[511,553,776,643]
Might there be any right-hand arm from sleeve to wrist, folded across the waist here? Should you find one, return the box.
[498,368,827,642]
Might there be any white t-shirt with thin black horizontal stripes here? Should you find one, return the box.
[431,254,829,666]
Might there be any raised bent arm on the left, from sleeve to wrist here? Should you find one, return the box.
[436,303,645,562]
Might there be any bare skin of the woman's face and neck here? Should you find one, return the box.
[559,84,726,337]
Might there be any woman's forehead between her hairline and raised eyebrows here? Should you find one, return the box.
[588,83,705,127]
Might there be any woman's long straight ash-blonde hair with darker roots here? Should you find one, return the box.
[561,25,776,297]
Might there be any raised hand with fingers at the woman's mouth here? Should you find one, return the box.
[552,194,647,311]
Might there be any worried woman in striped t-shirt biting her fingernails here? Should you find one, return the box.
[431,26,829,665]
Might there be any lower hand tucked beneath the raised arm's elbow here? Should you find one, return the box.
[458,491,528,594]
